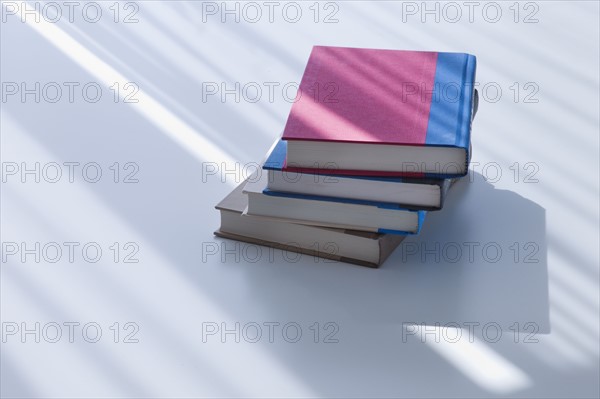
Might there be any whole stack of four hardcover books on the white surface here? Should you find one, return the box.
[215,46,477,267]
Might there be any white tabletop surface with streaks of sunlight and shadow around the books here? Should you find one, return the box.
[1,1,600,397]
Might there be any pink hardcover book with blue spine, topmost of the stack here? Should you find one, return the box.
[282,46,476,178]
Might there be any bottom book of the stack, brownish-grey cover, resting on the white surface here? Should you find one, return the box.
[215,182,405,268]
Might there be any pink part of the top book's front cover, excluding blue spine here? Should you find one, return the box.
[283,46,438,145]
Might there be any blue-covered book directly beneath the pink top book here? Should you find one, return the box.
[263,140,452,210]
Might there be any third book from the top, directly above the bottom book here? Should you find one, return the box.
[243,171,426,235]
